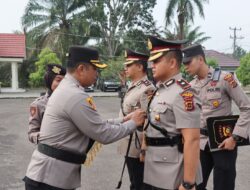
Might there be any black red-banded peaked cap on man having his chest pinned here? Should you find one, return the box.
[148,36,187,61]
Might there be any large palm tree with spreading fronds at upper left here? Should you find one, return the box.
[22,0,87,62]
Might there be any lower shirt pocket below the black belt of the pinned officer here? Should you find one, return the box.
[152,146,180,163]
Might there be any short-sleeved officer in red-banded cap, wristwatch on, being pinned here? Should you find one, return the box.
[144,36,201,190]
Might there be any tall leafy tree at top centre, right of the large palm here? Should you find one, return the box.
[85,0,156,58]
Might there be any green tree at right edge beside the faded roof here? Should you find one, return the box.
[236,53,250,86]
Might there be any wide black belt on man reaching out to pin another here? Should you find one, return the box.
[37,143,86,164]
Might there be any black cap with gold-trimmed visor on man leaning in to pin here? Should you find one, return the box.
[67,46,107,69]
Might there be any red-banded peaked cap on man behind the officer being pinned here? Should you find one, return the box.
[124,49,149,65]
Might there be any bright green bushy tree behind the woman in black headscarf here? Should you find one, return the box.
[29,48,61,87]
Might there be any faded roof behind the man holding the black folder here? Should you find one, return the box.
[205,50,240,67]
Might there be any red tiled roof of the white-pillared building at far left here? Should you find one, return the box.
[0,34,26,58]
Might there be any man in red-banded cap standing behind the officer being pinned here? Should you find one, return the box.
[118,49,155,190]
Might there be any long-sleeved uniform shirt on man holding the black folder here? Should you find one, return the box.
[191,67,250,150]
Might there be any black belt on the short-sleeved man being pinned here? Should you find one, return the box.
[146,135,182,146]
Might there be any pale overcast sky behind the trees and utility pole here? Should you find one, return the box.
[0,0,250,53]
